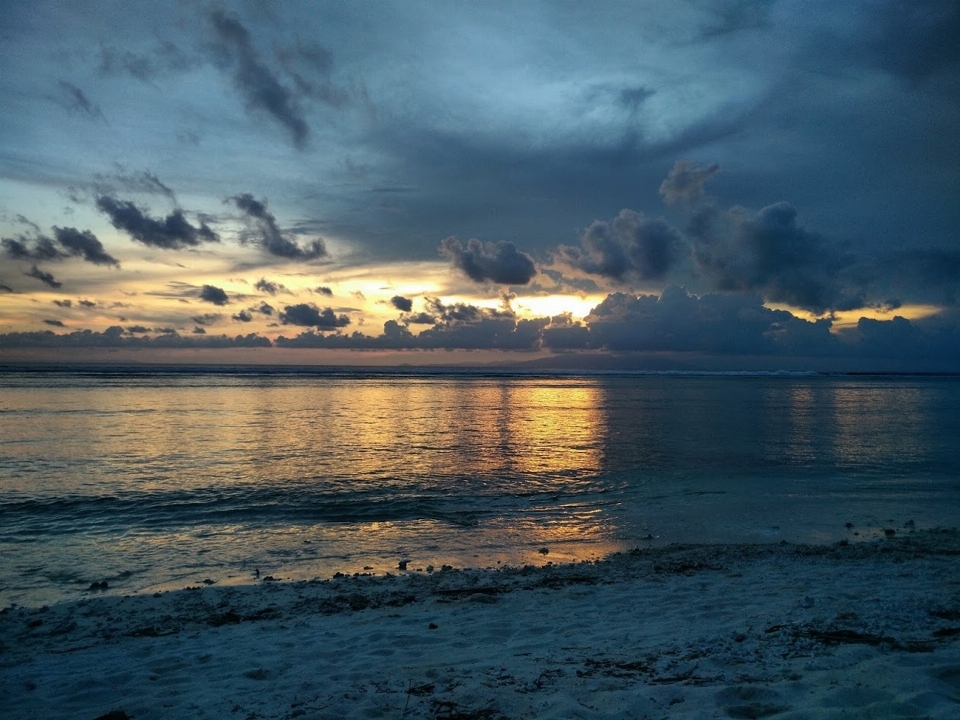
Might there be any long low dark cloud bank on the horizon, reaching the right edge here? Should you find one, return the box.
[227,286,960,369]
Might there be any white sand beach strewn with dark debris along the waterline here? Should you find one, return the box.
[0,529,960,720]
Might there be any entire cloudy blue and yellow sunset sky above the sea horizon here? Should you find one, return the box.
[0,0,960,371]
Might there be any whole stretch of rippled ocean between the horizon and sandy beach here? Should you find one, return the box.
[0,366,960,607]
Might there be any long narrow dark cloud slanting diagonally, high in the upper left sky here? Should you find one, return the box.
[210,9,310,148]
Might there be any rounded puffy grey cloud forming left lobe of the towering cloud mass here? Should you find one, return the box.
[556,210,682,280]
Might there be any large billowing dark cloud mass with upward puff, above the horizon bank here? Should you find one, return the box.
[608,160,877,314]
